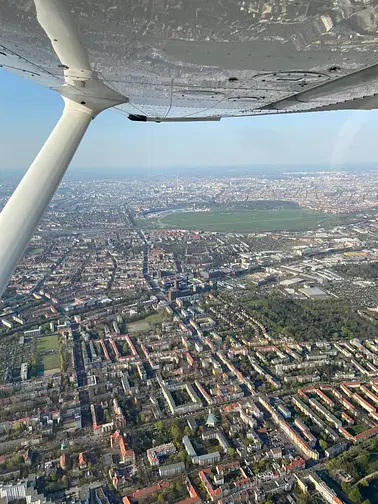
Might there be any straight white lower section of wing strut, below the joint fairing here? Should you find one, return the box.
[0,99,93,296]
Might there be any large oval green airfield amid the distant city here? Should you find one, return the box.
[158,208,348,233]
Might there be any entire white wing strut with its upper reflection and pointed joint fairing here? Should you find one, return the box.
[0,0,128,297]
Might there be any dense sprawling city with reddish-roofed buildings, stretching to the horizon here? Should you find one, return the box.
[0,172,378,504]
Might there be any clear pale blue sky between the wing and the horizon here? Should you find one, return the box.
[0,69,378,170]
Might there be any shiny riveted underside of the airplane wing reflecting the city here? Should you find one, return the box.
[0,0,378,122]
